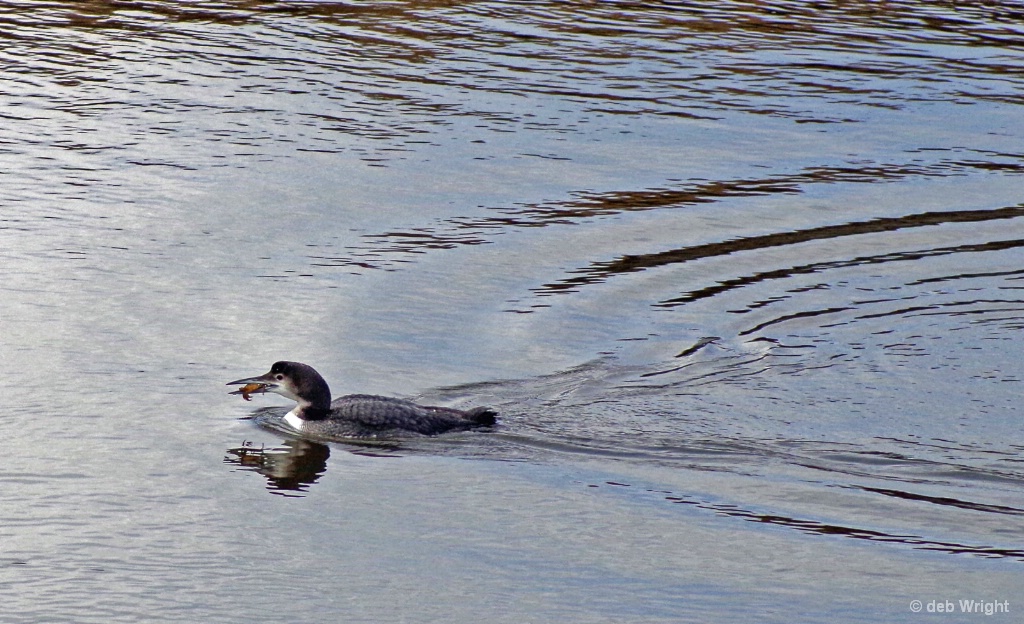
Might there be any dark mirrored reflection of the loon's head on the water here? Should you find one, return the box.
[224,439,331,496]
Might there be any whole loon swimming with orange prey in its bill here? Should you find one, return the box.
[227,362,498,438]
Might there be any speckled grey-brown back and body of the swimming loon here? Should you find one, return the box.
[302,394,498,438]
